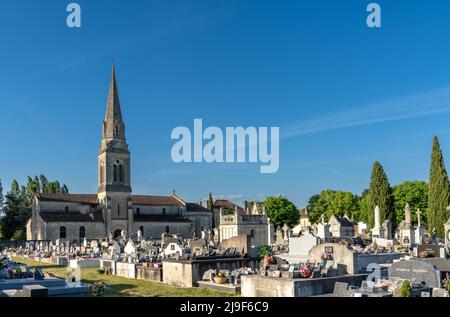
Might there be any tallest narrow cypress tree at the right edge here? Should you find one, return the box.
[428,137,450,237]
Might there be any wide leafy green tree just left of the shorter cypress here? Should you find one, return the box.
[307,189,360,222]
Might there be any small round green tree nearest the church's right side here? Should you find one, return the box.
[264,196,299,228]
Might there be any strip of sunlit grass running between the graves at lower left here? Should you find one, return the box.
[13,254,233,297]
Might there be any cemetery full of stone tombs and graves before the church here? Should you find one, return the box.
[0,200,450,297]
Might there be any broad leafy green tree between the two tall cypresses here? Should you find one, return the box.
[392,181,428,223]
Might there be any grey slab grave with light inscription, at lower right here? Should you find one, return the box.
[389,260,441,288]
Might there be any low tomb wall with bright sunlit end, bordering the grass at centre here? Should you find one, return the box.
[163,258,258,287]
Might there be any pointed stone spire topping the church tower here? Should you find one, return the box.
[103,64,125,139]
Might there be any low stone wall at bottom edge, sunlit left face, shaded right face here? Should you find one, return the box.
[241,274,368,297]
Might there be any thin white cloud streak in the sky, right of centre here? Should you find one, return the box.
[281,87,450,138]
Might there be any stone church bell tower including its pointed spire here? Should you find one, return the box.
[97,65,133,235]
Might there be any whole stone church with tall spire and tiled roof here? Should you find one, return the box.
[27,66,212,242]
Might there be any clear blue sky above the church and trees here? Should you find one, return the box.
[0,0,450,207]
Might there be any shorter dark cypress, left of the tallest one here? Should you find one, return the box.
[367,161,396,229]
